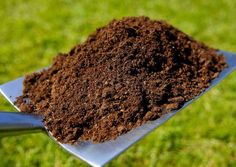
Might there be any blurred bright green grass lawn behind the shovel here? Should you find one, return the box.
[0,0,236,167]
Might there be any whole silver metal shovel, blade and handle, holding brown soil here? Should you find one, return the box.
[0,51,236,167]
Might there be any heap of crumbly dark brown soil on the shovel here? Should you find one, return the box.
[16,17,227,143]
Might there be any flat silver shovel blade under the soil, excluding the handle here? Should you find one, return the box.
[0,51,236,167]
